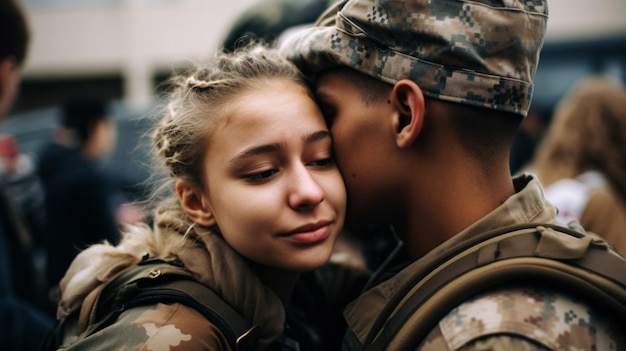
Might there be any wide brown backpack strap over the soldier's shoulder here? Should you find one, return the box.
[364,224,626,350]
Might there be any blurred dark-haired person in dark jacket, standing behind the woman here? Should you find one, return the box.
[37,91,119,308]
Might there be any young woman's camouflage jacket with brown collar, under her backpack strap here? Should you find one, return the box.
[57,224,285,351]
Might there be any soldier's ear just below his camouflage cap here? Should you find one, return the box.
[391,79,424,148]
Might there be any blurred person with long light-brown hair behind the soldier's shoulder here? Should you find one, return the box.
[529,76,626,255]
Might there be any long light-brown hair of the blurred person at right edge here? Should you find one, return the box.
[531,76,626,202]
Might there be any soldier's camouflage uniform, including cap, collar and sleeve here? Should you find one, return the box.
[280,0,626,351]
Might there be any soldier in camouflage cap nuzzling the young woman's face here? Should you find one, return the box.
[281,0,626,350]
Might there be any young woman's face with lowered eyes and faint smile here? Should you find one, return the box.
[204,81,346,271]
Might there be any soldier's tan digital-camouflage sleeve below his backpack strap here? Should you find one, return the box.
[417,287,626,351]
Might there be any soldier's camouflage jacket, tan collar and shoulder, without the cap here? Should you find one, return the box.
[344,175,626,351]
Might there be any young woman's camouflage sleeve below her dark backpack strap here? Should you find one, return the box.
[65,303,231,351]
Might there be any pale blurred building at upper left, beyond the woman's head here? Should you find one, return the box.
[13,0,256,112]
